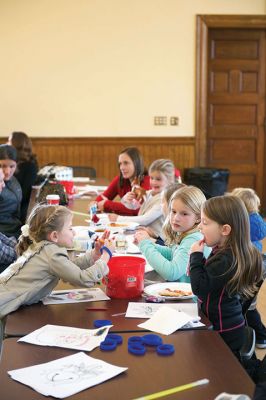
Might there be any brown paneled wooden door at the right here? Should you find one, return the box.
[207,29,265,196]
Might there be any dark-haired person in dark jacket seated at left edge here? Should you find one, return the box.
[0,144,22,238]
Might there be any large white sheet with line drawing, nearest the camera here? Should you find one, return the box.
[8,352,127,399]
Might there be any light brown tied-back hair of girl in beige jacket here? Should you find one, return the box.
[17,204,71,255]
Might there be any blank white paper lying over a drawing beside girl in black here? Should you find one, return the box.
[138,307,196,335]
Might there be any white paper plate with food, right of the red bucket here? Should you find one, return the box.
[144,282,194,300]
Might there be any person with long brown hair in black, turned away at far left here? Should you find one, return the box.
[8,132,38,223]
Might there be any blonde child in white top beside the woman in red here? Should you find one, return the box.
[109,159,175,236]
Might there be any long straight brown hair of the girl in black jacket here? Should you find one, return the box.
[202,196,262,297]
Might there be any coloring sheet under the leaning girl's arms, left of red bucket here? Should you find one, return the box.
[42,288,110,305]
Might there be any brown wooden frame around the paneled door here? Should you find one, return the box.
[195,15,266,210]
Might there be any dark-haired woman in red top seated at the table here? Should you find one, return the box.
[96,147,150,215]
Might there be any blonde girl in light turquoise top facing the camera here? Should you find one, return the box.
[135,186,211,282]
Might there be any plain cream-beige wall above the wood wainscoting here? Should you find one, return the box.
[0,0,266,137]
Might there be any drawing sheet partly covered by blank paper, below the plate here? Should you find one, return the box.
[126,302,199,321]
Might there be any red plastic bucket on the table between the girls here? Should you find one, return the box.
[103,256,146,299]
